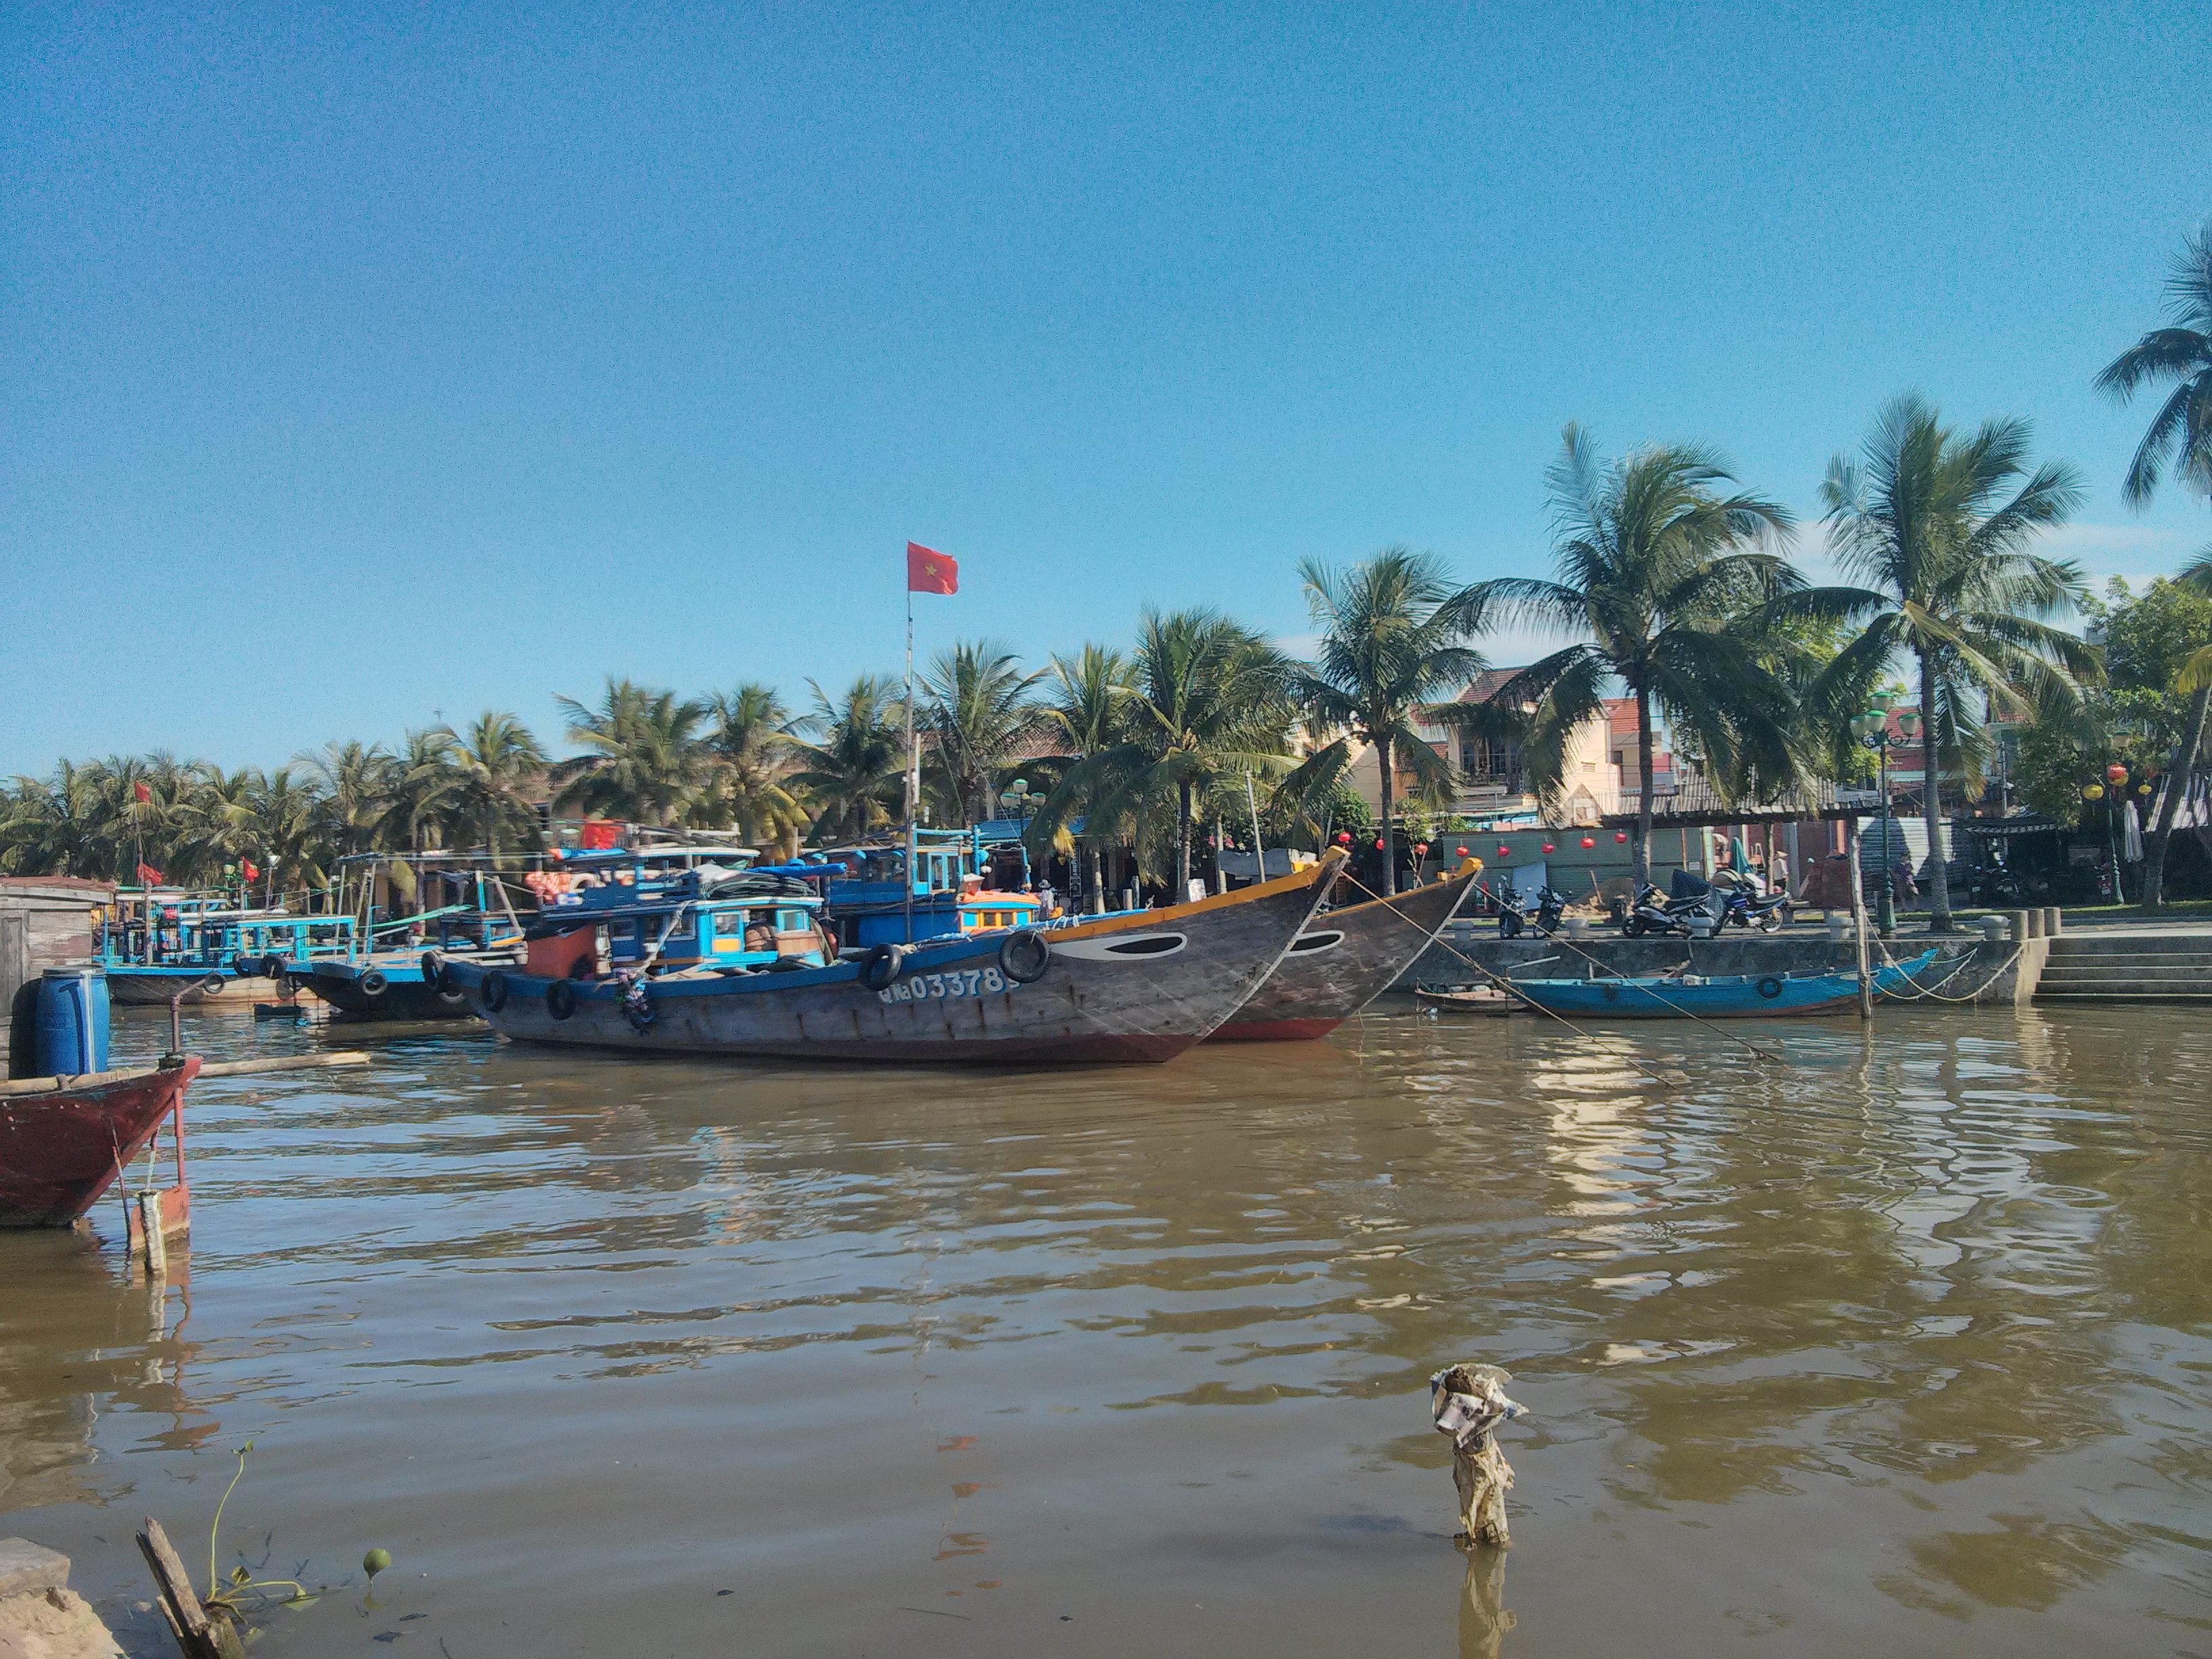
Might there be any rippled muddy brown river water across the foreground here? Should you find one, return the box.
[0,1006,2212,1659]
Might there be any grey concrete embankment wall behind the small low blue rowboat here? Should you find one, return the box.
[1396,922,2051,1004]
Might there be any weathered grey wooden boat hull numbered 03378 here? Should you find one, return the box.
[426,854,1343,1066]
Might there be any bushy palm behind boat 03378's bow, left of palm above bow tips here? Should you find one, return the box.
[1038,611,1292,898]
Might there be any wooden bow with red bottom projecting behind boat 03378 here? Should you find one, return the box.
[1208,869,1480,1042]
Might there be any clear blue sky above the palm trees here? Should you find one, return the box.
[0,0,2212,772]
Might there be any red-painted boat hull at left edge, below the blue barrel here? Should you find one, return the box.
[0,1055,199,1228]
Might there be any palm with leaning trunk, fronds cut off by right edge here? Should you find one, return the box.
[2097,219,2212,909]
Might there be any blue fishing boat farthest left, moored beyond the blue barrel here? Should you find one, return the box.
[91,887,356,1008]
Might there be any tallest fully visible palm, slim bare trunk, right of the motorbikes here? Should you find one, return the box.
[1787,394,2097,933]
